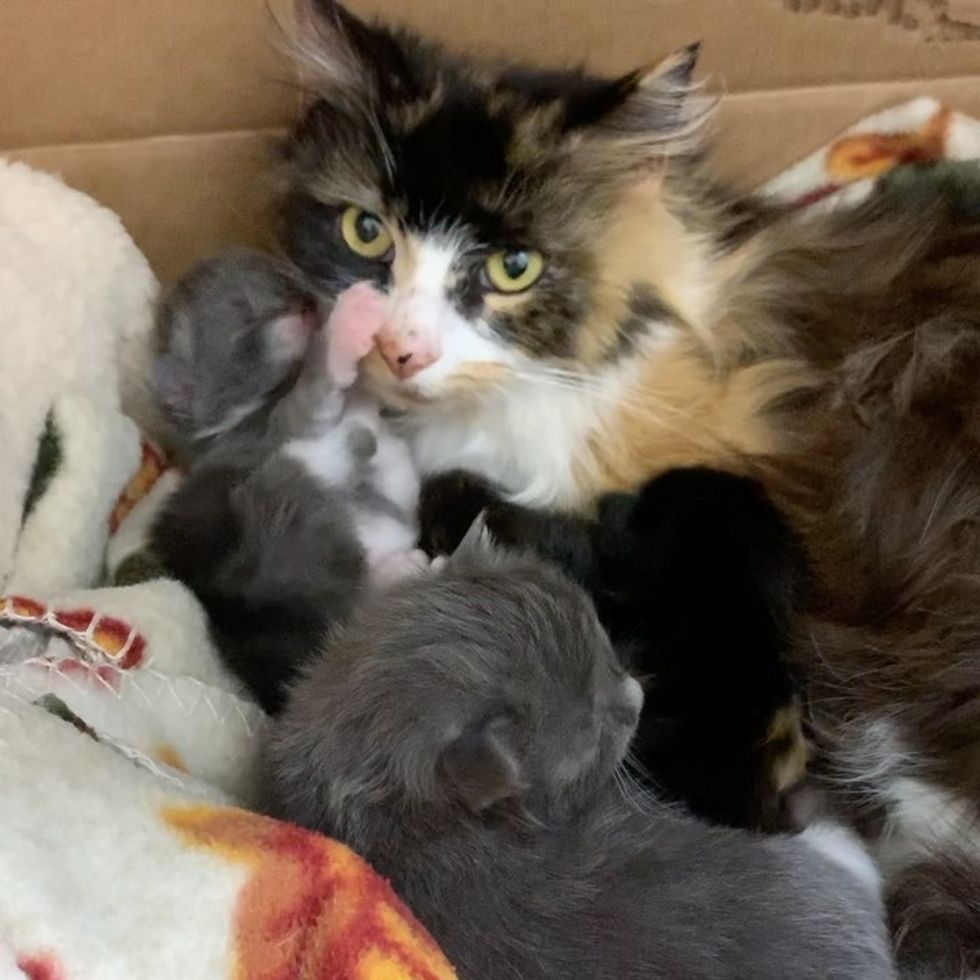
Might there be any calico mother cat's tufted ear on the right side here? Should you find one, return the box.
[586,44,714,166]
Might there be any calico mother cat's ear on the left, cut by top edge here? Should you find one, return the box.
[291,0,411,109]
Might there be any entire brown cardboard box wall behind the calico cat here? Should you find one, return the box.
[0,0,980,279]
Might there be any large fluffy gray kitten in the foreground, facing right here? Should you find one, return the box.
[265,536,894,980]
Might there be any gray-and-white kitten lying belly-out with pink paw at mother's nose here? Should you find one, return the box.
[151,251,427,711]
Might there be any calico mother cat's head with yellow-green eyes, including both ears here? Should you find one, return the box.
[283,0,695,404]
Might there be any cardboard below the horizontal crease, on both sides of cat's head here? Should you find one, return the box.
[13,78,980,280]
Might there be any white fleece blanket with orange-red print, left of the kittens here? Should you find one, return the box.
[0,160,453,980]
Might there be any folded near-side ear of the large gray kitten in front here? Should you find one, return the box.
[439,716,525,813]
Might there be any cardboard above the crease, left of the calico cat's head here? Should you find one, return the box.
[0,0,297,147]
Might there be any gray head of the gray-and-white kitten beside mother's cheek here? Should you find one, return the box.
[154,249,370,462]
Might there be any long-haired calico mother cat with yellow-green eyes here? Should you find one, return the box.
[282,0,980,972]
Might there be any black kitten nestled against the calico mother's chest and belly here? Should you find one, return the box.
[419,468,812,831]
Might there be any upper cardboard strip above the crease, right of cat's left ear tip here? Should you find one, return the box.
[348,0,980,91]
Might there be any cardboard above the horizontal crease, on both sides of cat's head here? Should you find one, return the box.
[0,0,980,147]
